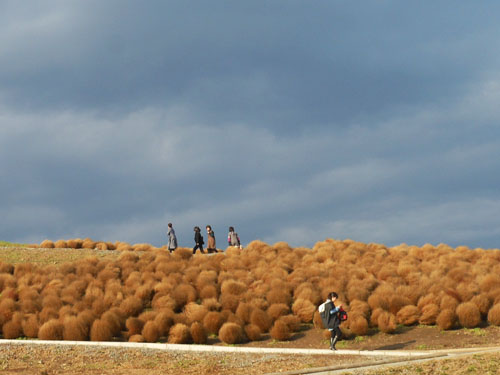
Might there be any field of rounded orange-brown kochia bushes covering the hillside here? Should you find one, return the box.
[0,239,500,344]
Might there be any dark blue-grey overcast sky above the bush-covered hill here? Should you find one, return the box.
[0,0,500,248]
